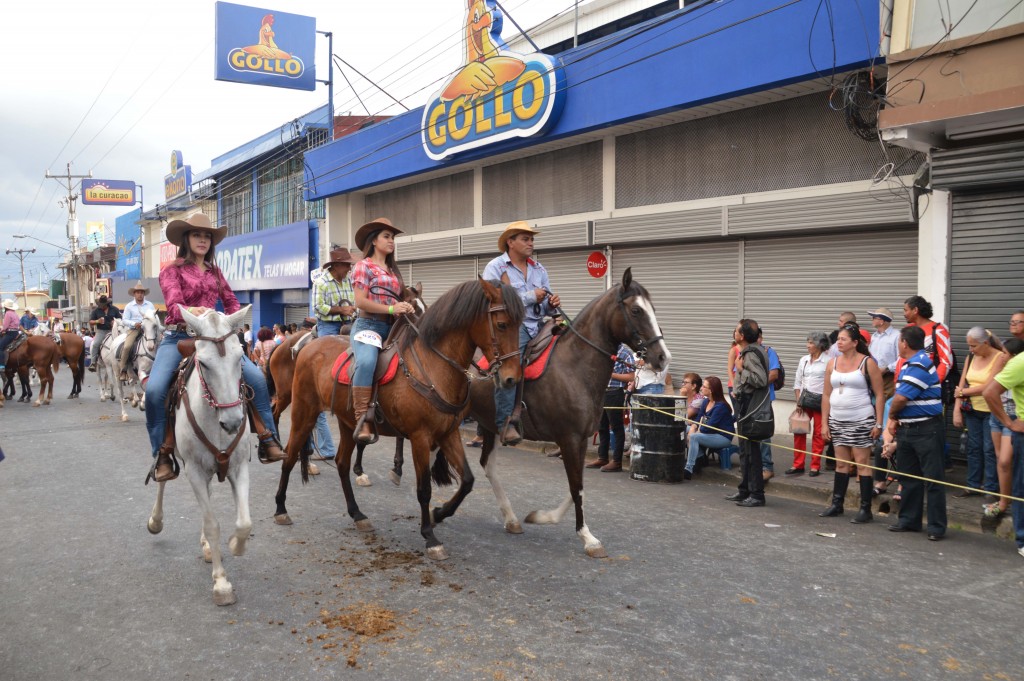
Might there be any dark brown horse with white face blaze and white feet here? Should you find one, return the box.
[372,268,672,558]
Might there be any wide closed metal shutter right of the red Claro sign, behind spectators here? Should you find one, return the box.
[745,229,918,385]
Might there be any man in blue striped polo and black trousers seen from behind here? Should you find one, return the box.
[885,327,946,542]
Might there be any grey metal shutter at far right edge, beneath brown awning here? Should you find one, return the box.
[947,189,1024,360]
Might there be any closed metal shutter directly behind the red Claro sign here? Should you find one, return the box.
[611,242,739,386]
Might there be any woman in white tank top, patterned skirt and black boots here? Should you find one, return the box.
[818,323,885,523]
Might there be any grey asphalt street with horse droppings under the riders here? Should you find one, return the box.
[0,367,1024,681]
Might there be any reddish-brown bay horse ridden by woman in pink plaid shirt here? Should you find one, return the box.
[274,279,524,560]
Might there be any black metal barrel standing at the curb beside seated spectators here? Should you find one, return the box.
[630,395,687,482]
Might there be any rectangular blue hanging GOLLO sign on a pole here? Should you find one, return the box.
[214,2,316,90]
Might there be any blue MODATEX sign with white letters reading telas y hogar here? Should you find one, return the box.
[216,222,309,291]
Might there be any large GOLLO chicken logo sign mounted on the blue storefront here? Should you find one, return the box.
[421,0,565,161]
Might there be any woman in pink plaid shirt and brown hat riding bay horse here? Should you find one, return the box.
[350,217,413,442]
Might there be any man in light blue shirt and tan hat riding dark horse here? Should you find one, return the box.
[483,220,561,444]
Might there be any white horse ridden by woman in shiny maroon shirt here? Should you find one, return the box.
[147,305,253,605]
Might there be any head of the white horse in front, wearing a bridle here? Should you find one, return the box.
[178,305,250,433]
